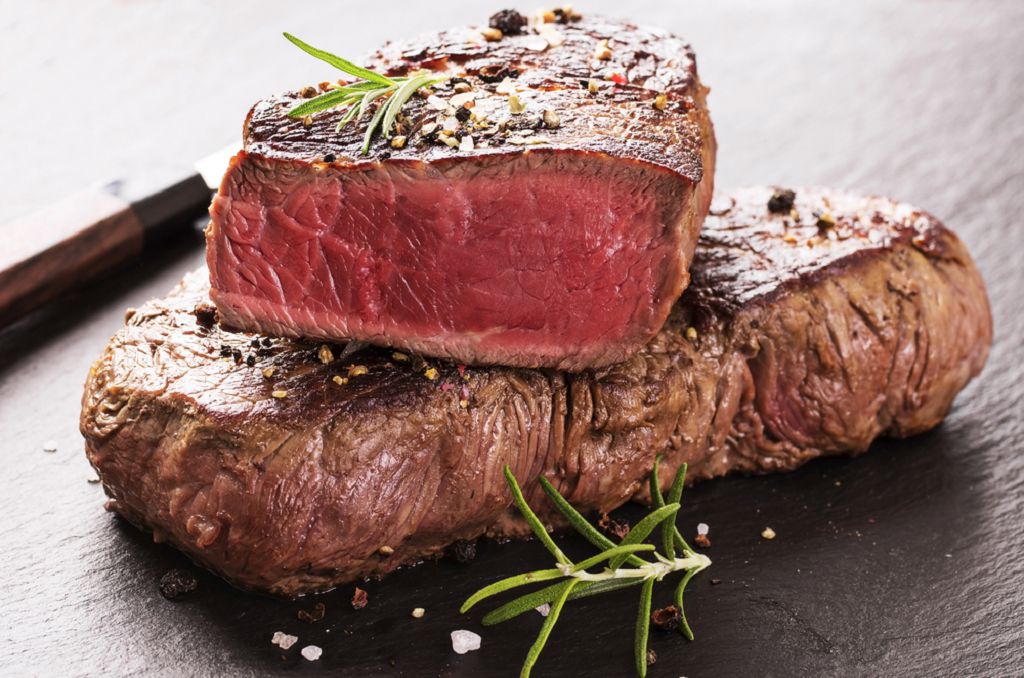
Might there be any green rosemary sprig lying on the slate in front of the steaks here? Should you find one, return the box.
[461,457,711,678]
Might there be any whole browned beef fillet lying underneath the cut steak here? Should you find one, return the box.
[81,188,991,595]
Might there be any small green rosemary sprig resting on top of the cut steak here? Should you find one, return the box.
[285,33,449,156]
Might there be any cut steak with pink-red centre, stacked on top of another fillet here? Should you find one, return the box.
[207,13,715,371]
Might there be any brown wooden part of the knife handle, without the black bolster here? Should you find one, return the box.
[0,189,143,328]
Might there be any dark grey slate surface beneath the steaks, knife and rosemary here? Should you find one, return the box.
[0,0,1024,678]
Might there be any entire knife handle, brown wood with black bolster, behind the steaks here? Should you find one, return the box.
[0,175,210,328]
